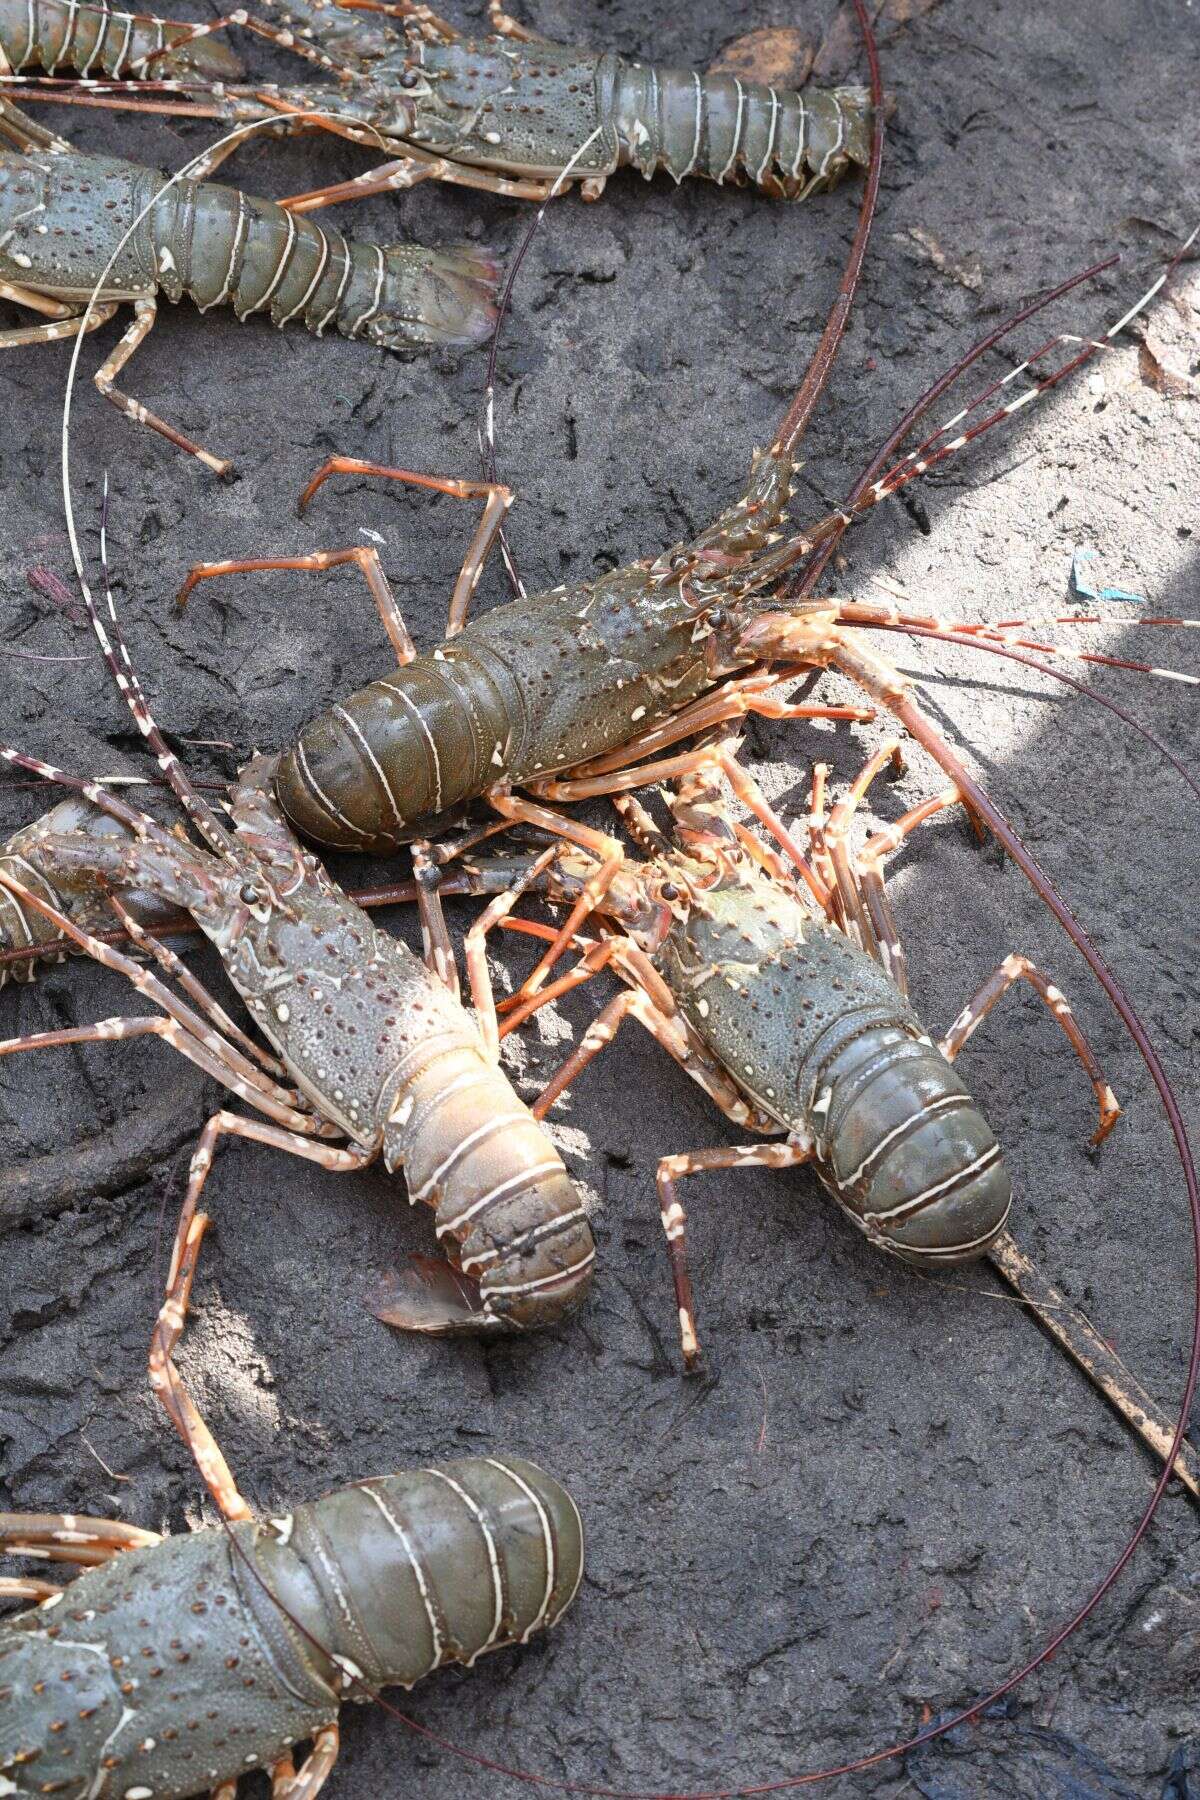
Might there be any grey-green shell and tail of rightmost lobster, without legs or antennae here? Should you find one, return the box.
[655,859,1011,1264]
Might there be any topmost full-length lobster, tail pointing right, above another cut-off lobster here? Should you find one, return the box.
[5,0,871,212]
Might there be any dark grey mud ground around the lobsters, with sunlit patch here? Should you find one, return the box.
[0,0,1200,1800]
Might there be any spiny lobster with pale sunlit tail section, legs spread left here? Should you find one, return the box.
[0,500,596,1353]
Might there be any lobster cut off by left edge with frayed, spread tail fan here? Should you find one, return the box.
[0,99,498,475]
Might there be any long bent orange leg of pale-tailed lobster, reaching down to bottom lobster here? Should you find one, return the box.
[149,1111,376,1519]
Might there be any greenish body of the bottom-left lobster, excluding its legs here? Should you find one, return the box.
[0,1456,583,1800]
